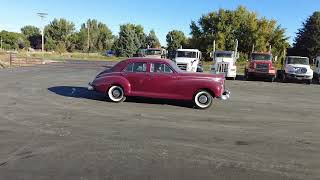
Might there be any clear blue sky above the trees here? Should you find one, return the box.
[0,0,320,45]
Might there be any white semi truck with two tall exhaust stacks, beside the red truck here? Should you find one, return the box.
[211,40,239,80]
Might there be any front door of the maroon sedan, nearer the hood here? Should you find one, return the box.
[145,62,178,99]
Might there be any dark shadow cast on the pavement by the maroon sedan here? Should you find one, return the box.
[48,86,193,108]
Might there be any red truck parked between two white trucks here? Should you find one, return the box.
[245,52,276,82]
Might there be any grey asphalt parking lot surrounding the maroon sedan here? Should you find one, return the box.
[0,61,320,180]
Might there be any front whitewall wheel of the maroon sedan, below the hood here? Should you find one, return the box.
[193,90,213,109]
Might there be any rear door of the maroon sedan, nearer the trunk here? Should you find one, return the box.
[122,62,147,96]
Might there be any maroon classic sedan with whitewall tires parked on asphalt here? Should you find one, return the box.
[88,58,230,109]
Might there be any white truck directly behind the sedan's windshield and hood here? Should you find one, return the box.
[174,49,203,72]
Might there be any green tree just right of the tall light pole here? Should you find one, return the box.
[45,19,75,50]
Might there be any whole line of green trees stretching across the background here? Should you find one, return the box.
[0,6,320,58]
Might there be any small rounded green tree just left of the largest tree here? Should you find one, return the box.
[166,30,187,51]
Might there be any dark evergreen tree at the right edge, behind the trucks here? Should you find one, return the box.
[293,11,320,58]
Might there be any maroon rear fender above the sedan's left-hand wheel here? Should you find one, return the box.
[92,76,131,95]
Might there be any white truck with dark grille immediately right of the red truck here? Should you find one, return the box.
[281,56,313,84]
